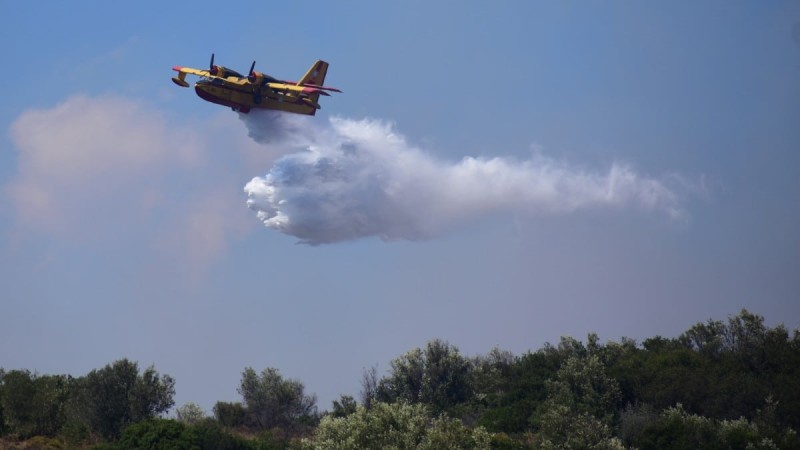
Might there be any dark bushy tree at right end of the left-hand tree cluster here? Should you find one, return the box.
[81,359,175,438]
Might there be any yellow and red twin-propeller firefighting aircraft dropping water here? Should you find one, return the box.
[172,53,342,116]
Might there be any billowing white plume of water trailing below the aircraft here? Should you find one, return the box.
[244,114,683,244]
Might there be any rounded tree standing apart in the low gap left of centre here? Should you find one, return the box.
[238,367,317,433]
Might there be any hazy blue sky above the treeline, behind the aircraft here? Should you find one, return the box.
[0,1,800,411]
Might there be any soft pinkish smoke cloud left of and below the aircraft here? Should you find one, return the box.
[5,96,202,235]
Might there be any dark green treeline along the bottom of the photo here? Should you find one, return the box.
[0,310,800,450]
